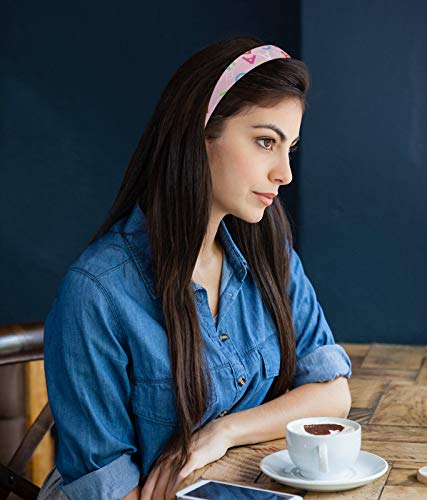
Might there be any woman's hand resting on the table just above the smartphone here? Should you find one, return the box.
[140,419,230,500]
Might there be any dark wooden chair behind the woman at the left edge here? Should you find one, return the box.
[0,323,54,500]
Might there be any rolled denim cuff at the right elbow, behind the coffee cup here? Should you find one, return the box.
[293,344,351,388]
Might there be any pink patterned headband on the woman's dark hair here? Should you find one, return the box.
[205,45,291,127]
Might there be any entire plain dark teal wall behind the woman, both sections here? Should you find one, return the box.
[0,0,427,344]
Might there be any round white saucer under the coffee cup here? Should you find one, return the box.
[259,450,388,491]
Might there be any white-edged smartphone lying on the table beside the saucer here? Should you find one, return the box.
[176,479,303,500]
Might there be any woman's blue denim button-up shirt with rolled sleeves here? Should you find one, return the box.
[44,203,351,499]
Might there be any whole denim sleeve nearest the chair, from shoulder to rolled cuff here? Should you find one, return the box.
[44,268,140,500]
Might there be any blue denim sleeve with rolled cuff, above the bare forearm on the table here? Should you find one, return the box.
[289,249,352,388]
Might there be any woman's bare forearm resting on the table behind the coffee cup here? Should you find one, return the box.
[221,377,351,447]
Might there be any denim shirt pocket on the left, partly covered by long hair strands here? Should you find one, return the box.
[131,378,218,426]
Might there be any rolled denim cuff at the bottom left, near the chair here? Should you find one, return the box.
[60,454,141,500]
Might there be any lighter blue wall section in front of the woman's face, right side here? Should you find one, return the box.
[298,0,427,344]
